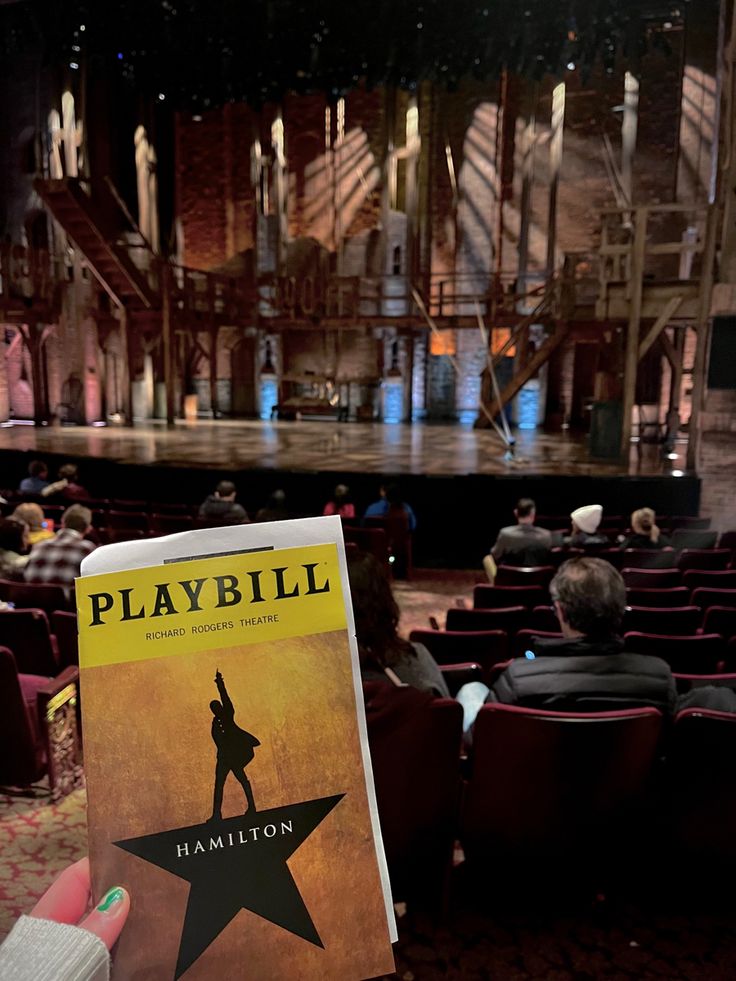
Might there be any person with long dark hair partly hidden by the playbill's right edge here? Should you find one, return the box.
[347,552,450,698]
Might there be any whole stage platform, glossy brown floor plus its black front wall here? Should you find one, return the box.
[0,420,700,568]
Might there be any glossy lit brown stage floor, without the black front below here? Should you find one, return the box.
[0,420,686,477]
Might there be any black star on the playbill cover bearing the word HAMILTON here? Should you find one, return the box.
[114,794,345,978]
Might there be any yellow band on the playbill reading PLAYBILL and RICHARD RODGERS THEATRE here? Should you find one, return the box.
[77,543,346,668]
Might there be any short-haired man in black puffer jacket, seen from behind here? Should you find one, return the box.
[458,556,677,728]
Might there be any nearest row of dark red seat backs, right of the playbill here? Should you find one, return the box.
[364,683,736,900]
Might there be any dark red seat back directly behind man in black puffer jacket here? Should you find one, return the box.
[461,703,662,867]
